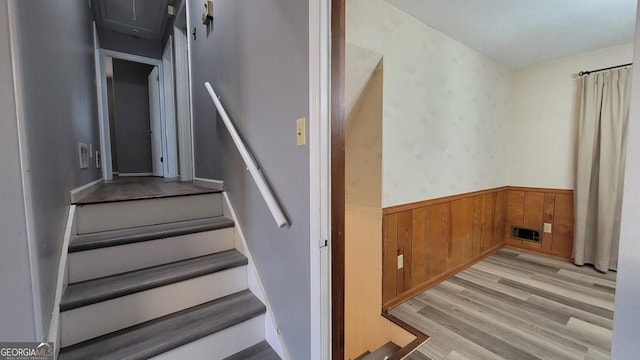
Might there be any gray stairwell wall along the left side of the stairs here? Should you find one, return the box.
[8,0,101,341]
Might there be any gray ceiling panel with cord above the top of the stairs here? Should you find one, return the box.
[91,0,175,41]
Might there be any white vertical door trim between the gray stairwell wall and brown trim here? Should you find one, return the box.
[307,0,332,360]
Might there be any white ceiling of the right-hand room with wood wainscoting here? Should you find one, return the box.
[385,0,636,68]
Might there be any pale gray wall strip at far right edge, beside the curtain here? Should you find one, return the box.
[611,7,640,360]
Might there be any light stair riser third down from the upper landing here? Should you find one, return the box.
[60,266,246,347]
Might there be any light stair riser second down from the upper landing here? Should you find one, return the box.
[68,228,234,283]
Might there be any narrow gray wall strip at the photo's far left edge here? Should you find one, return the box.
[0,1,36,341]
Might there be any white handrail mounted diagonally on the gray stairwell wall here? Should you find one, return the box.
[204,82,290,228]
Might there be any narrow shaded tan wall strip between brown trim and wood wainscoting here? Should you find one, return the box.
[345,44,414,359]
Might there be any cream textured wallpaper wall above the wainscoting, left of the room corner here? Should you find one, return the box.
[346,0,511,207]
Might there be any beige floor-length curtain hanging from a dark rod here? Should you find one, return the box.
[573,68,631,272]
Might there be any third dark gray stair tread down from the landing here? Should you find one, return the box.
[58,290,266,360]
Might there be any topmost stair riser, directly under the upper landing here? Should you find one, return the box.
[77,194,222,234]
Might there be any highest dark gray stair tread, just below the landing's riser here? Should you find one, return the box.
[69,216,234,253]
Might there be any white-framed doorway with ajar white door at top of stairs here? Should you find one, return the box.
[98,49,178,180]
